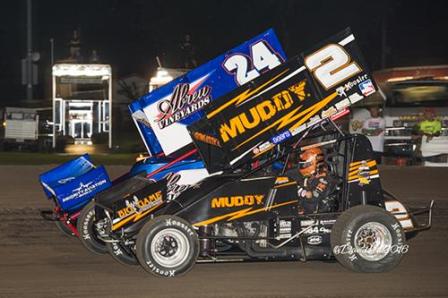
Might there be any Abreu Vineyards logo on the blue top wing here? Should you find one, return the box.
[156,74,212,129]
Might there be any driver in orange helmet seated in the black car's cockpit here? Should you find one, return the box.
[297,147,337,214]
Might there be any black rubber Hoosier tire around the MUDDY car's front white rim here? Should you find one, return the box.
[136,216,199,277]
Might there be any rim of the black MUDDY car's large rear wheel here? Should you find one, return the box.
[354,222,392,262]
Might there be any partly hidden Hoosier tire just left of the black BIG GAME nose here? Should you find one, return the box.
[77,202,107,255]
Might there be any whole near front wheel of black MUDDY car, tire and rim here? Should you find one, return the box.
[136,215,199,277]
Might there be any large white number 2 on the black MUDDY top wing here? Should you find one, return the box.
[305,44,362,90]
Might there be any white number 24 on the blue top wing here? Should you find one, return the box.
[223,40,282,85]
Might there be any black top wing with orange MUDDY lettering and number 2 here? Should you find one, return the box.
[188,29,377,173]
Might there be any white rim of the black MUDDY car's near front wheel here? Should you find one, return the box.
[151,228,190,268]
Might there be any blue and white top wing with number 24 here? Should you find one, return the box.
[129,29,286,156]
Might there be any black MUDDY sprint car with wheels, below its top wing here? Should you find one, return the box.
[95,129,433,277]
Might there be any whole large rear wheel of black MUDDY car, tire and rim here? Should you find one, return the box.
[331,205,408,272]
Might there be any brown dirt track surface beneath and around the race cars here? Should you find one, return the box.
[0,166,448,297]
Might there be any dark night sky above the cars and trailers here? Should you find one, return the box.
[0,0,448,102]
